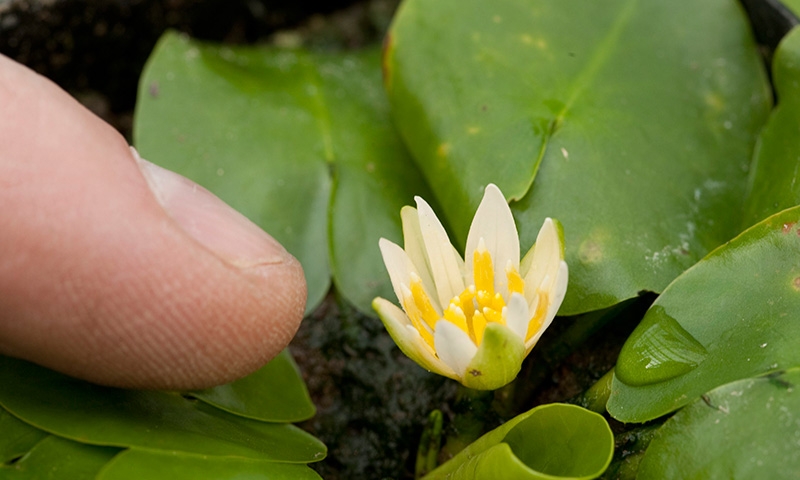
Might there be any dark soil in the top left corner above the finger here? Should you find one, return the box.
[0,0,397,139]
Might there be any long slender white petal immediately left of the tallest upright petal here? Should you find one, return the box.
[415,197,464,306]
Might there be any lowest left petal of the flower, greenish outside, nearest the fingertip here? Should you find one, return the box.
[372,297,460,380]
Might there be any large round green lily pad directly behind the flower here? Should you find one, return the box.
[385,0,771,315]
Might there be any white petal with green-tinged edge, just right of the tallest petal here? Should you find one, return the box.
[520,218,564,299]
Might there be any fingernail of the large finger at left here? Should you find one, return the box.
[131,148,291,269]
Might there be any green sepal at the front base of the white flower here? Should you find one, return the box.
[461,323,525,390]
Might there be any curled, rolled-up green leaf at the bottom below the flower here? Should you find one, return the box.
[424,403,614,480]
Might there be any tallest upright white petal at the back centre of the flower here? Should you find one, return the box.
[464,183,519,298]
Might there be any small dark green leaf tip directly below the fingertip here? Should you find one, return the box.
[191,350,316,422]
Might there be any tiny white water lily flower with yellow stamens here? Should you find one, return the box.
[372,184,567,390]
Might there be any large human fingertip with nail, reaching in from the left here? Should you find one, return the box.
[0,55,306,389]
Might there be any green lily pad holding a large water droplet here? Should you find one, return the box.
[607,206,800,422]
